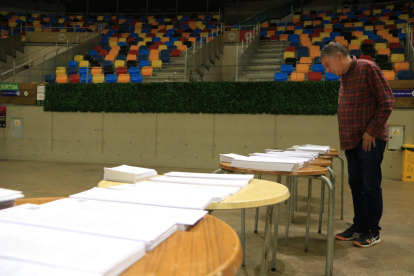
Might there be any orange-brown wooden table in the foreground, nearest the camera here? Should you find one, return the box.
[16,197,243,276]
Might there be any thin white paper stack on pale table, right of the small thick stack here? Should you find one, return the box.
[151,176,250,188]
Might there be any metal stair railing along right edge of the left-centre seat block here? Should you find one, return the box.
[184,26,223,82]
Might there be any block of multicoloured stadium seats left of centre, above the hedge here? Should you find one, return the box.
[45,16,217,83]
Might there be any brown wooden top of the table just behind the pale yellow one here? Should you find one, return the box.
[220,162,329,176]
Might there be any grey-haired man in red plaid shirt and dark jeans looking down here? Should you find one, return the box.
[321,42,394,247]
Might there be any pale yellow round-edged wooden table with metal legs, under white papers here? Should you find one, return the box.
[98,179,290,275]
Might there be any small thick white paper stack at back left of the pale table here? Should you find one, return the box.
[104,165,157,183]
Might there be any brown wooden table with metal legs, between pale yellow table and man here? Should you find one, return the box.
[215,162,335,276]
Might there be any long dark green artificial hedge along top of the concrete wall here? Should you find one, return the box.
[44,81,340,115]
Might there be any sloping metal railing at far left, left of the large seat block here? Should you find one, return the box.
[0,33,101,83]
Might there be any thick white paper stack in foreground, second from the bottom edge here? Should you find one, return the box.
[0,221,145,276]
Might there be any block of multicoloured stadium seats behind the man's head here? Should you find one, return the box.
[266,3,414,81]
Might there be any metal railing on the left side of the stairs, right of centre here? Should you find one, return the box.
[234,24,260,81]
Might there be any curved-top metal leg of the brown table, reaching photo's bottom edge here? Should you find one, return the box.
[317,175,335,276]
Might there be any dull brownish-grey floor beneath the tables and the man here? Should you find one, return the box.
[0,160,414,276]
